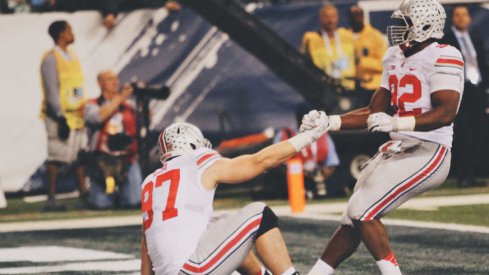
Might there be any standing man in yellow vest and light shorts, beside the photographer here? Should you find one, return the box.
[41,21,88,211]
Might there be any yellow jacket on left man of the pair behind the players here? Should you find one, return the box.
[301,28,355,90]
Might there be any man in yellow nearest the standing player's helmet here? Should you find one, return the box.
[348,5,387,104]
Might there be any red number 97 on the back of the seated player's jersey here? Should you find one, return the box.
[141,169,180,230]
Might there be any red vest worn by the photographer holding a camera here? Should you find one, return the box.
[87,96,138,163]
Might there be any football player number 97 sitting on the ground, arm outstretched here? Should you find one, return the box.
[141,119,328,275]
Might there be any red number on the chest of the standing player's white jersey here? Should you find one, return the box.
[389,74,421,116]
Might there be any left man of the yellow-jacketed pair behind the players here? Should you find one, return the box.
[301,4,355,90]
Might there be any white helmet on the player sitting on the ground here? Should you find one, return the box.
[159,122,212,162]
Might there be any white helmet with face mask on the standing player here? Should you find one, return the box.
[387,0,447,46]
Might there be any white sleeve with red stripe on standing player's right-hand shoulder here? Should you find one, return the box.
[428,45,464,93]
